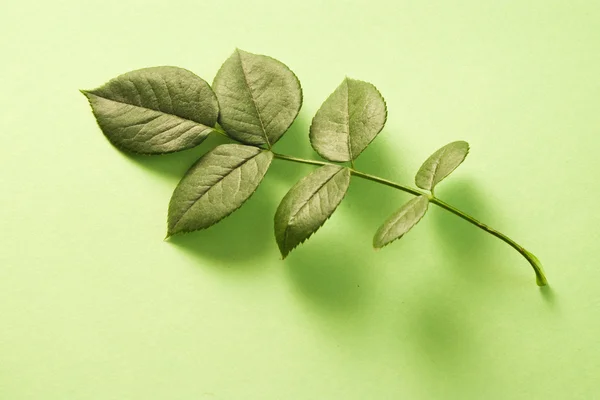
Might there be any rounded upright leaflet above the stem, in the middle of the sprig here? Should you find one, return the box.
[310,78,387,162]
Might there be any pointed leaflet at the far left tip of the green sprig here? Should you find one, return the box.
[82,67,219,154]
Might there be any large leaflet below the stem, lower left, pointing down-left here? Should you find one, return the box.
[168,144,273,236]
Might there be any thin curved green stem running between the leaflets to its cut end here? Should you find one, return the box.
[273,153,548,286]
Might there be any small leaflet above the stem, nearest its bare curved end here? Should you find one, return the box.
[415,140,469,190]
